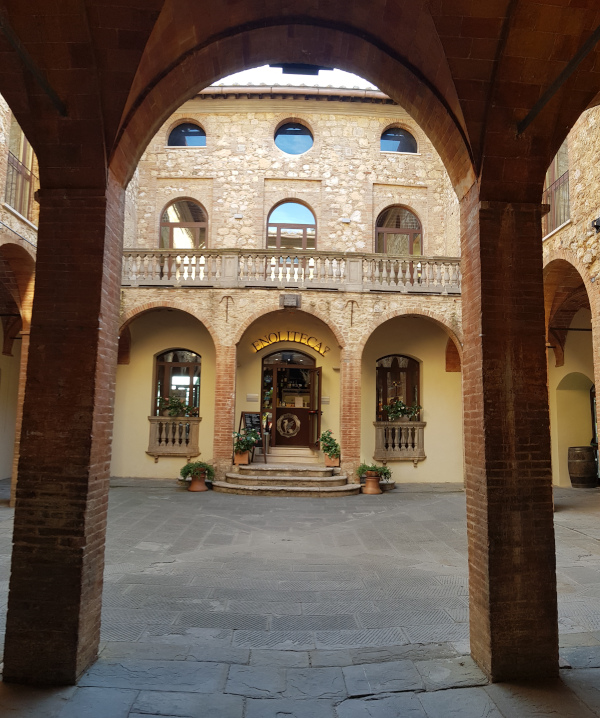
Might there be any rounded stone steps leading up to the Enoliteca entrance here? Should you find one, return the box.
[213,462,360,497]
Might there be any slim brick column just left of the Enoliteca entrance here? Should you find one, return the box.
[213,344,237,478]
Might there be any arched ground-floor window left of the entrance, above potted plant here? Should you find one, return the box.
[154,349,202,416]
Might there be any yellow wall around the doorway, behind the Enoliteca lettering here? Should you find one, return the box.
[235,310,343,451]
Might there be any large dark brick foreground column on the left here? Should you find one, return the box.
[4,181,124,685]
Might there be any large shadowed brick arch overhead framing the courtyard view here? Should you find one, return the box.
[110,23,475,197]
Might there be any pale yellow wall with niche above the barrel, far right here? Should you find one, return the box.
[548,309,594,486]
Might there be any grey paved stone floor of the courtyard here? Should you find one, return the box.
[0,481,600,718]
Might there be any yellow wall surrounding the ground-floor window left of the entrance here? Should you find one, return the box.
[111,310,215,478]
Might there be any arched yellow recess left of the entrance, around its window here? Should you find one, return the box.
[111,305,217,478]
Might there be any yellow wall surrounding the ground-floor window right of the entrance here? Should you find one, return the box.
[361,317,464,483]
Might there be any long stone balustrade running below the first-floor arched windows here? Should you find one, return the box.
[122,249,461,294]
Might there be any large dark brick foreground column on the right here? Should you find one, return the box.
[461,188,558,681]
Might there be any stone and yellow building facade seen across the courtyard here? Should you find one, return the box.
[112,87,463,482]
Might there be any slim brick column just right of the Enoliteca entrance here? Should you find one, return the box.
[340,347,360,483]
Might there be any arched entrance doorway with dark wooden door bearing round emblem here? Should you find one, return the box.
[262,351,322,449]
